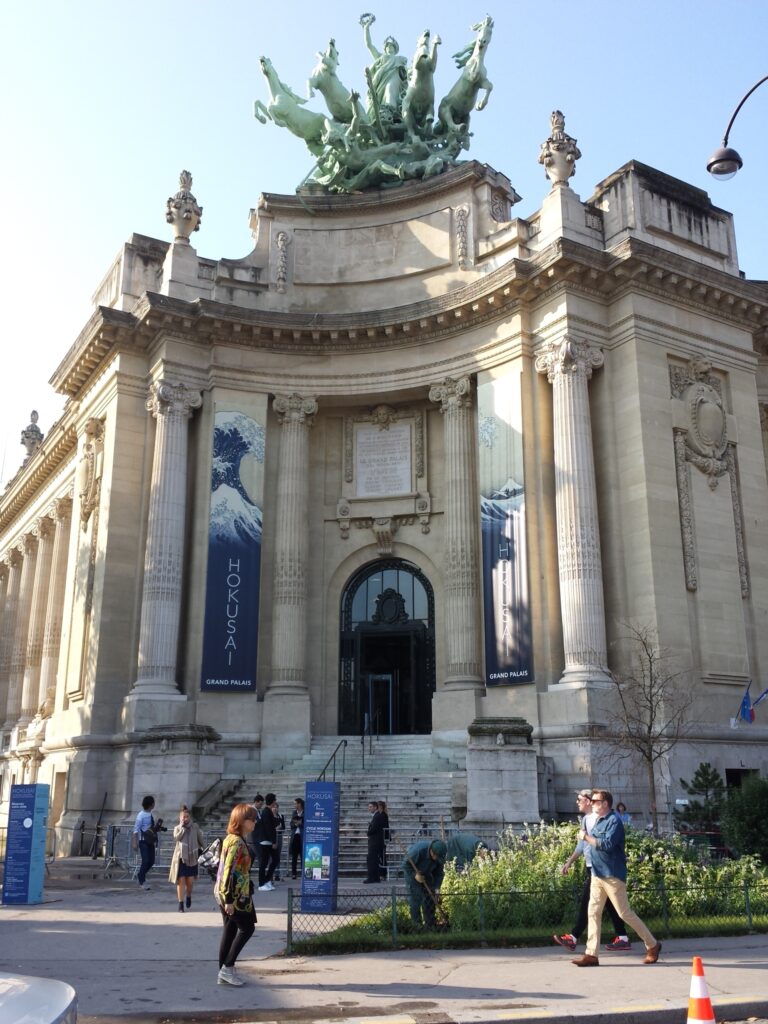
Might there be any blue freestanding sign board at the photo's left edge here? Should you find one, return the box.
[3,785,50,903]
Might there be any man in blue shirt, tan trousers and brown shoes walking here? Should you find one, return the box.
[572,790,662,967]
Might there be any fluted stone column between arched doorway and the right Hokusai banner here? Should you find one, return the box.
[429,377,482,689]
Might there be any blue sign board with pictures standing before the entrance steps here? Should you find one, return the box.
[301,782,341,913]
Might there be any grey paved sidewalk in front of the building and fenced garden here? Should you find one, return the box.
[0,878,768,1024]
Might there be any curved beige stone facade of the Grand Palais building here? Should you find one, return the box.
[0,162,768,826]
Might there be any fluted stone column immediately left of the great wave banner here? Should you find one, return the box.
[131,381,202,697]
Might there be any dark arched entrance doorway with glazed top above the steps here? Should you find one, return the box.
[339,558,435,735]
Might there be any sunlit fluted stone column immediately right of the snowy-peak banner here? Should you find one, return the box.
[536,336,610,685]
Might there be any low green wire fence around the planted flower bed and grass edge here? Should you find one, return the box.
[287,878,768,953]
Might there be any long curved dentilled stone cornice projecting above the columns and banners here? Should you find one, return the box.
[51,234,768,397]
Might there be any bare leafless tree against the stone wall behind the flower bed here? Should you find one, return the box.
[606,623,693,835]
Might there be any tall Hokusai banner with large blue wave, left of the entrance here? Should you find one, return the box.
[201,410,265,692]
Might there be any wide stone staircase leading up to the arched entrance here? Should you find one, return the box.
[204,736,466,879]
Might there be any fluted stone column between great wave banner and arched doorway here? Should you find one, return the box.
[268,394,317,695]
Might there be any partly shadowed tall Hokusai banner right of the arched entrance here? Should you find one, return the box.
[477,370,534,686]
